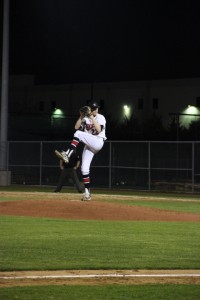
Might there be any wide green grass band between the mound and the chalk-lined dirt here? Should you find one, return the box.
[0,216,200,271]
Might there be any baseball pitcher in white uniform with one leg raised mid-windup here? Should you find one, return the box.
[55,102,106,201]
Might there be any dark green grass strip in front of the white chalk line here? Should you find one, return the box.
[0,284,200,300]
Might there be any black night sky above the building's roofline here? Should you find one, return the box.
[0,0,200,84]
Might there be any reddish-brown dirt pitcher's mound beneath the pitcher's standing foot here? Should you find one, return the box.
[0,192,200,222]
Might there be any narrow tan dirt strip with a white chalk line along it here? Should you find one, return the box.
[0,270,200,287]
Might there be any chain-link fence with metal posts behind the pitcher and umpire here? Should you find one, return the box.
[1,141,200,193]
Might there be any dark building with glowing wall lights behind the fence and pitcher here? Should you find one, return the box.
[2,75,200,140]
